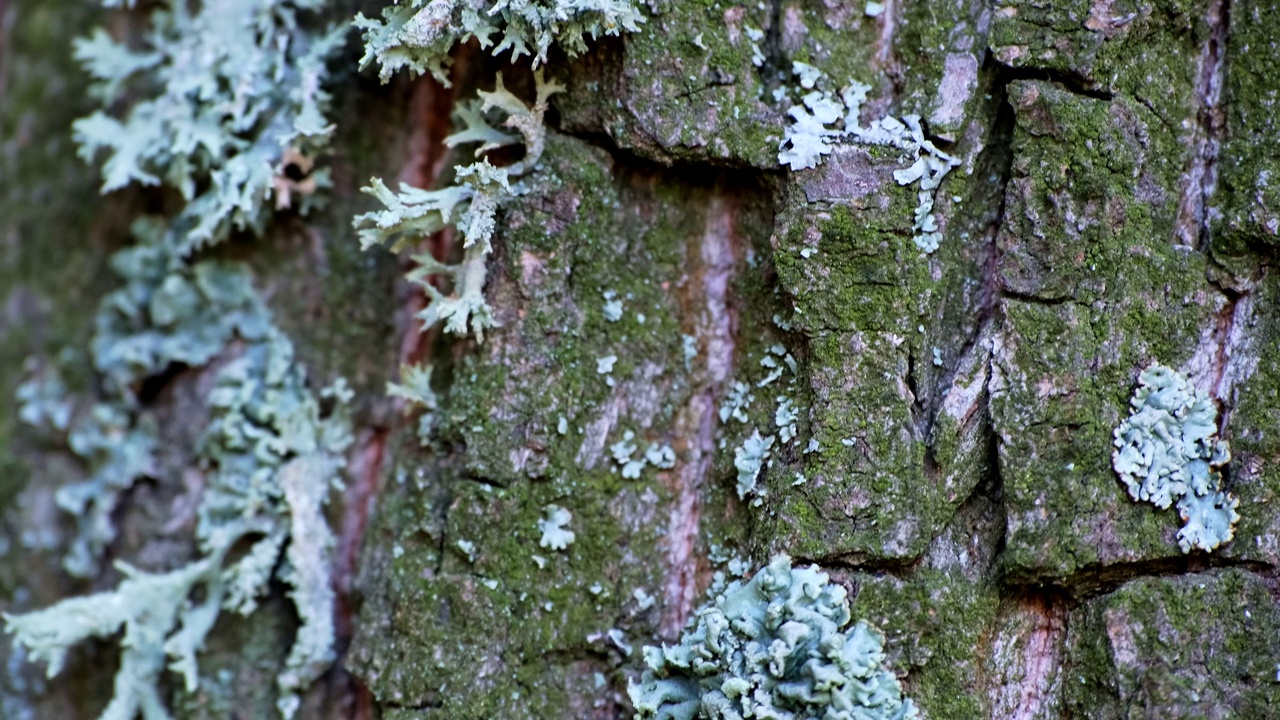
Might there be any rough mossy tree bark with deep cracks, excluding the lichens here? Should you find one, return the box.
[0,0,1280,720]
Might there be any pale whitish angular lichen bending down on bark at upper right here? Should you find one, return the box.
[778,63,960,252]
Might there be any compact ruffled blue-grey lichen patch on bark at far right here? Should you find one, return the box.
[1111,364,1240,552]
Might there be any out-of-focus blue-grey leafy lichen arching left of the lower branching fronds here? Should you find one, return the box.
[20,233,270,577]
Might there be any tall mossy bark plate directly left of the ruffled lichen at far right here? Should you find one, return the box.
[991,82,1228,578]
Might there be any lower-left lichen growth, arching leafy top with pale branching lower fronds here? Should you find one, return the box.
[5,242,351,720]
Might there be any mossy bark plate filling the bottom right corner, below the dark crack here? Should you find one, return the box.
[1062,569,1280,720]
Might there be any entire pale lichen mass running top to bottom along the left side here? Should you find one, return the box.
[5,0,351,720]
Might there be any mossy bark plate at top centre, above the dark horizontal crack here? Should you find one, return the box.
[563,1,877,170]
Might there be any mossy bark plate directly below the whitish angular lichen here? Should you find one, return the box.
[764,120,991,561]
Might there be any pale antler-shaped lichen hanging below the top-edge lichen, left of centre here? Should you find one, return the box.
[355,72,562,341]
